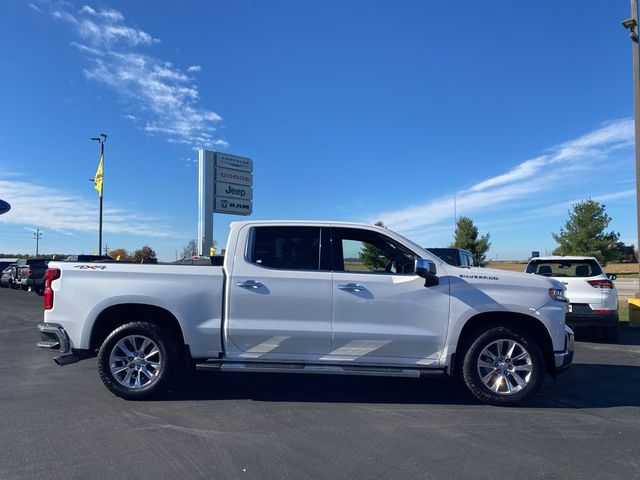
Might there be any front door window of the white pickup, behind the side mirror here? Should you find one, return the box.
[333,228,417,274]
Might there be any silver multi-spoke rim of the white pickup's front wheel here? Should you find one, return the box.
[477,339,533,395]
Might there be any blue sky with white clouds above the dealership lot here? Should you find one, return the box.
[0,0,636,260]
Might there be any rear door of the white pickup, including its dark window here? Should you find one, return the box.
[226,226,332,359]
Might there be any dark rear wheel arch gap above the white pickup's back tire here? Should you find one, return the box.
[89,303,185,350]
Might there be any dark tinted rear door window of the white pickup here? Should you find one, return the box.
[249,227,320,270]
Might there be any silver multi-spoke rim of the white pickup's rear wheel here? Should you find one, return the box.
[109,335,163,389]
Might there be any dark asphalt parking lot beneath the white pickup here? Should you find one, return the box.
[0,289,640,480]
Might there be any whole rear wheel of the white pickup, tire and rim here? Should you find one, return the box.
[98,322,179,400]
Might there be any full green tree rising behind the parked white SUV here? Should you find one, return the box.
[552,198,620,265]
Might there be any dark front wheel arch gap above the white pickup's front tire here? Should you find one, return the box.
[455,312,554,372]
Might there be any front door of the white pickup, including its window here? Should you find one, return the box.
[327,228,449,366]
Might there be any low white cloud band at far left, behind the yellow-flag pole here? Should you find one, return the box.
[0,176,174,237]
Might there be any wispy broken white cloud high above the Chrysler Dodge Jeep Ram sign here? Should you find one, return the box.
[46,5,228,148]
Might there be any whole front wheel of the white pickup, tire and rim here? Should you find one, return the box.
[462,326,546,406]
